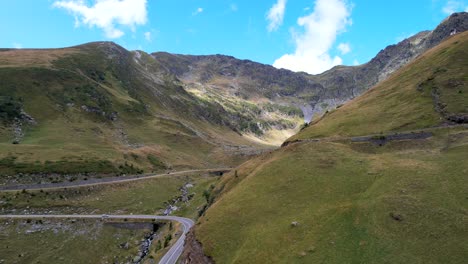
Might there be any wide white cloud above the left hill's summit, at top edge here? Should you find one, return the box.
[53,0,148,38]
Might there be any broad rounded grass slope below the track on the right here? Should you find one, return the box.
[197,127,468,263]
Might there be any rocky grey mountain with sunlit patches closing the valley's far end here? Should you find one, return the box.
[152,13,468,143]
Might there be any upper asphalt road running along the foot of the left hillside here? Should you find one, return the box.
[0,168,231,191]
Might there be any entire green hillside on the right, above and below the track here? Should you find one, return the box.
[195,30,468,263]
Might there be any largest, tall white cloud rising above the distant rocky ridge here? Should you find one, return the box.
[273,0,352,74]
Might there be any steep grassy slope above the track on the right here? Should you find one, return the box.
[289,33,468,140]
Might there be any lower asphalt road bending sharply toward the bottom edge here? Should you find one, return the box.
[0,215,194,264]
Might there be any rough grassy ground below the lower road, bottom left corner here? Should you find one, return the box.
[0,220,151,263]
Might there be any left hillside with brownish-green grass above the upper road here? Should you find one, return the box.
[0,42,262,180]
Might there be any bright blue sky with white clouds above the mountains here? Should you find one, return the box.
[0,0,468,73]
